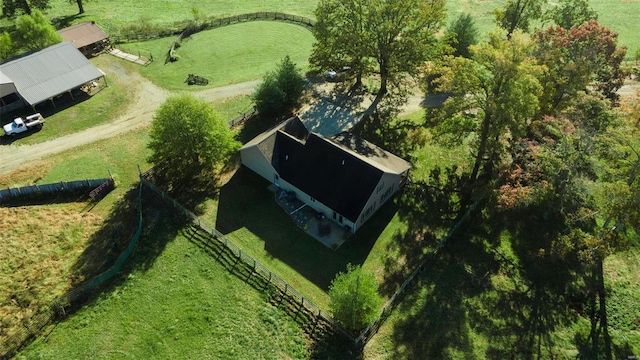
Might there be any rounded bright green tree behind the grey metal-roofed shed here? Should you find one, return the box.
[15,10,62,51]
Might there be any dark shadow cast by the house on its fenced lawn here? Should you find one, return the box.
[215,166,384,291]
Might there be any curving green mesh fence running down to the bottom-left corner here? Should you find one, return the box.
[0,183,142,360]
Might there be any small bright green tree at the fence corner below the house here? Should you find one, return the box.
[329,264,382,330]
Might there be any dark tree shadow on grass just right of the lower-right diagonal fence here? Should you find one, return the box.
[392,219,497,359]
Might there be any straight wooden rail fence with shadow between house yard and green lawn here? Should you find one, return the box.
[140,174,354,340]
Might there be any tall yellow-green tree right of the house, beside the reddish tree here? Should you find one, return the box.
[427,33,541,185]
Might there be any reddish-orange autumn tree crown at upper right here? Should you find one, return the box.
[534,20,626,114]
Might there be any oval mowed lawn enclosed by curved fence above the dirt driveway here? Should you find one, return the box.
[123,21,314,90]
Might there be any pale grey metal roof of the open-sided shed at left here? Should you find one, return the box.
[0,42,104,107]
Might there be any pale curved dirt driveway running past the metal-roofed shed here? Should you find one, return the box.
[0,59,258,174]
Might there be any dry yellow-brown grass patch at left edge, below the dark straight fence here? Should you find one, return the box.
[0,203,103,343]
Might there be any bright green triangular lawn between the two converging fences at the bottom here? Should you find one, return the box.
[16,218,307,360]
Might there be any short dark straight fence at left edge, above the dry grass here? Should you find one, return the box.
[0,177,115,205]
